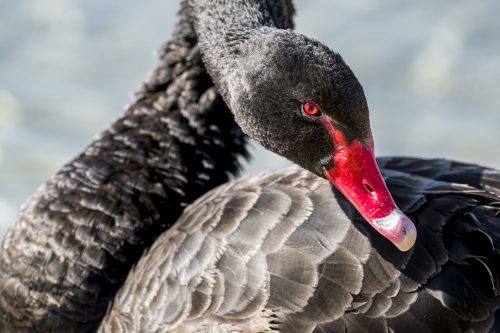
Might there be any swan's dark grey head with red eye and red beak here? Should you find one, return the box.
[224,28,416,251]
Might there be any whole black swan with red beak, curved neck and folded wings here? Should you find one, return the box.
[0,0,500,332]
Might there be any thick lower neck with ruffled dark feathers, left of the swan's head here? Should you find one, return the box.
[0,3,247,332]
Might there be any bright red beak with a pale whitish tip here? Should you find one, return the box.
[321,116,417,251]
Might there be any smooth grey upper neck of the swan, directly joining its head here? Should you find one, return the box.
[189,0,294,103]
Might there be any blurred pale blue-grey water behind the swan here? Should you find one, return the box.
[0,0,500,234]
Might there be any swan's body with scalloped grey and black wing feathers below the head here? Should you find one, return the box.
[100,158,500,333]
